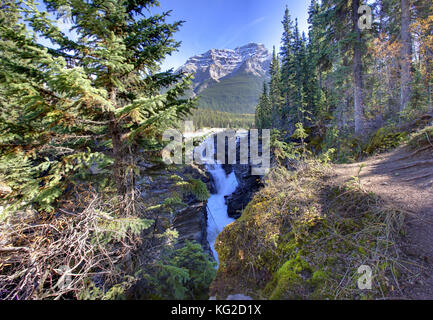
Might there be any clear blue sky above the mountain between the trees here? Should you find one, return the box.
[151,0,310,69]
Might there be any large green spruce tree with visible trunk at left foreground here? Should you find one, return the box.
[0,0,194,214]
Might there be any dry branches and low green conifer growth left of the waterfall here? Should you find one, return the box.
[0,162,215,300]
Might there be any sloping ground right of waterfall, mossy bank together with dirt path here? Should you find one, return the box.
[211,127,433,300]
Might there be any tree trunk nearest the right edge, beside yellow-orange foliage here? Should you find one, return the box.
[400,0,412,111]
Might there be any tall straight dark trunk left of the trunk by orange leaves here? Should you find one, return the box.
[352,0,365,136]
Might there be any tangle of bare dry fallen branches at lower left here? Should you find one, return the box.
[0,189,144,300]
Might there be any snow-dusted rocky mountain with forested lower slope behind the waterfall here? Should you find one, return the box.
[176,43,272,113]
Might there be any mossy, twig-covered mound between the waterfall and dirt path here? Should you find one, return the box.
[212,161,403,299]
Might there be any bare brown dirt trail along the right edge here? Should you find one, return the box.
[334,147,433,299]
